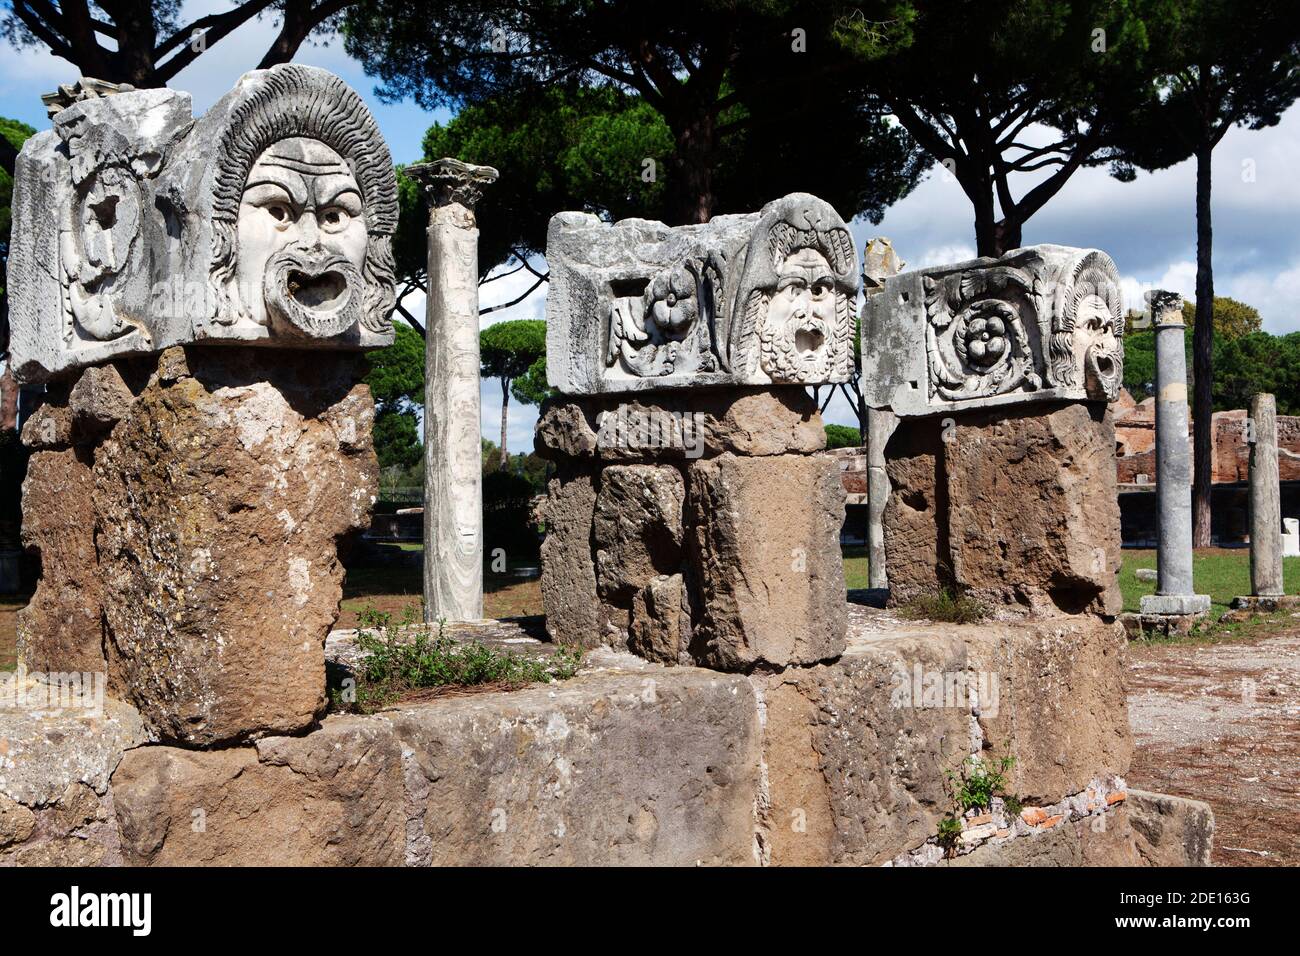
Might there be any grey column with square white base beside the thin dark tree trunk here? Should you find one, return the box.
[1141,290,1210,614]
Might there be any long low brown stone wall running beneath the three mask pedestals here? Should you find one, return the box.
[0,606,1209,866]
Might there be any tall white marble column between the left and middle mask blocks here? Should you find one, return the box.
[406,159,497,622]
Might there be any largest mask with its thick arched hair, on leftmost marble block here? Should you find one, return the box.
[211,64,398,338]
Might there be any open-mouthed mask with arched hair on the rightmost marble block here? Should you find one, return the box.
[1048,252,1125,402]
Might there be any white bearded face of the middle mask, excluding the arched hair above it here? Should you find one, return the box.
[758,247,837,381]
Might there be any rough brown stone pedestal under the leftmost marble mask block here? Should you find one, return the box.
[20,346,378,747]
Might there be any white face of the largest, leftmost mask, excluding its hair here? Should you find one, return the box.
[235,137,369,338]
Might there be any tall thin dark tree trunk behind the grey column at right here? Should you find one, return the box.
[1192,139,1214,548]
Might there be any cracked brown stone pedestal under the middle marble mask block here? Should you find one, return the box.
[537,388,845,671]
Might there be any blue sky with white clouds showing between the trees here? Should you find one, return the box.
[10,0,1300,451]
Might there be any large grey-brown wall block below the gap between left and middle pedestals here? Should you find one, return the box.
[394,667,759,866]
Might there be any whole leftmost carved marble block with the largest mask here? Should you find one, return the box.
[9,64,398,381]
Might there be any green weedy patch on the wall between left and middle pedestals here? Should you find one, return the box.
[330,605,582,714]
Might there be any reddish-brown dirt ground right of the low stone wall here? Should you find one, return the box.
[1128,611,1300,866]
